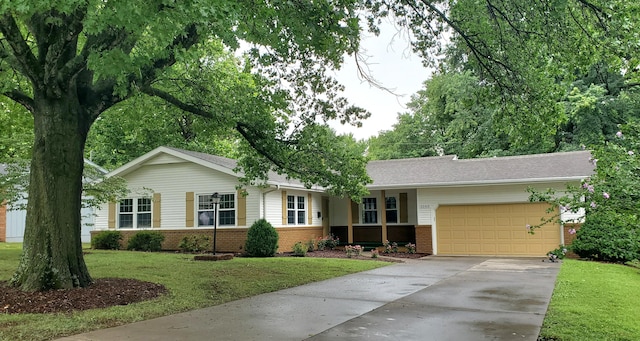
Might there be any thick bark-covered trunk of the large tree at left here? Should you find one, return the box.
[11,90,92,291]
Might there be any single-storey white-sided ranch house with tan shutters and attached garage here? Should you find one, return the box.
[92,147,593,256]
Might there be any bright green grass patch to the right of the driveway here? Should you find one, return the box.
[540,260,640,341]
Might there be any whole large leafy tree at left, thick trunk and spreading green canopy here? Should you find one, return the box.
[0,0,368,290]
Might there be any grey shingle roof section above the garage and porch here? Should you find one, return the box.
[367,151,594,188]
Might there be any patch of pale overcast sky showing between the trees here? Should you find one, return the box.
[330,20,431,139]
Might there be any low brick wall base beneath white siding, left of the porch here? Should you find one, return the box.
[91,226,322,253]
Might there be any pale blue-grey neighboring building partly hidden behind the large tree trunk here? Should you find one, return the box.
[0,159,107,243]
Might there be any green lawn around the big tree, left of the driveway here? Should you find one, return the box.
[0,243,388,340]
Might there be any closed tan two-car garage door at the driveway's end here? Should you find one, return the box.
[436,203,560,256]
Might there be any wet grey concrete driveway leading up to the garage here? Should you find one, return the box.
[60,257,559,341]
